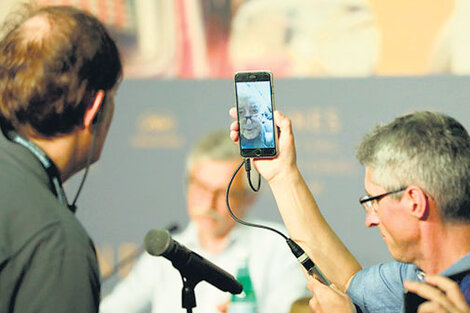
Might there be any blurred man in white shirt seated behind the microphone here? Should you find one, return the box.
[100,131,306,313]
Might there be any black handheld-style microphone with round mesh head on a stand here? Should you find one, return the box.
[145,229,243,294]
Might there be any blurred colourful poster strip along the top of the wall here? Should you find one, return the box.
[19,0,470,79]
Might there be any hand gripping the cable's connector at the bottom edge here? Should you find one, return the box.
[307,277,356,313]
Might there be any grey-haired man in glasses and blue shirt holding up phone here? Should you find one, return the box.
[231,109,470,313]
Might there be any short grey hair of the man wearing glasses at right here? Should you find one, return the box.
[357,111,470,222]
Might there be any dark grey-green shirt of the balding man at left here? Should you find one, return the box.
[0,127,100,313]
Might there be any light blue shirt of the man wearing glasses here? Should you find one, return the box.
[346,253,470,313]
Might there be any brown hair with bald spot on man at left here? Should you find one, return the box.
[0,6,122,137]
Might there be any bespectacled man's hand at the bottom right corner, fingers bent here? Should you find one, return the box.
[404,276,470,313]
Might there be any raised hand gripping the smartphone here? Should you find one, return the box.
[230,108,297,182]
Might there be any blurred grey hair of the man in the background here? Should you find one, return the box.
[186,129,241,174]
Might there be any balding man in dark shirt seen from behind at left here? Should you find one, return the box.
[0,6,122,313]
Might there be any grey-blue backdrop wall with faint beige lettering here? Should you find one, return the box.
[66,76,470,293]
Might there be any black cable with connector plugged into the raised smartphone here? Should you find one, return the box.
[225,158,330,286]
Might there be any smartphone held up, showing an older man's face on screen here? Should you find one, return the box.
[234,71,277,158]
